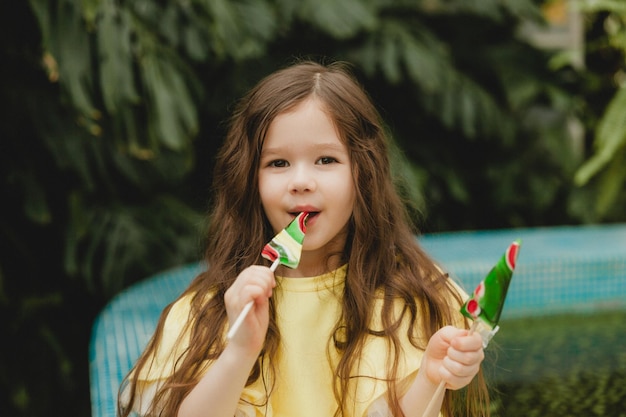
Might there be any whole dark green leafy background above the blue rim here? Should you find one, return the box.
[0,0,626,416]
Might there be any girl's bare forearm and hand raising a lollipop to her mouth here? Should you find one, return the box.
[178,266,276,417]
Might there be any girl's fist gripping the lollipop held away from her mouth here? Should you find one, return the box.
[422,326,485,390]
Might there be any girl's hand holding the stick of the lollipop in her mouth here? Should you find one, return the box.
[224,265,276,357]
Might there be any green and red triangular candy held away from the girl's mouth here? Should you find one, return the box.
[461,240,521,336]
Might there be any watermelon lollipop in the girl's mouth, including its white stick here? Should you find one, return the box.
[226,212,309,339]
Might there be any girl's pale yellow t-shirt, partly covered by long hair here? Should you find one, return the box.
[136,266,464,417]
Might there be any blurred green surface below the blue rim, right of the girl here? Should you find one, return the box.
[490,310,626,417]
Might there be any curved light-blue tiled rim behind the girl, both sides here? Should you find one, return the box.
[90,224,626,417]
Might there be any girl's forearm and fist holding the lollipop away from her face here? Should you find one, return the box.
[400,326,485,417]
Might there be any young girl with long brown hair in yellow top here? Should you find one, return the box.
[119,62,488,417]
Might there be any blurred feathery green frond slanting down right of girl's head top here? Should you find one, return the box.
[351,18,511,139]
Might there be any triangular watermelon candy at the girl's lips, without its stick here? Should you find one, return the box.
[261,212,309,268]
